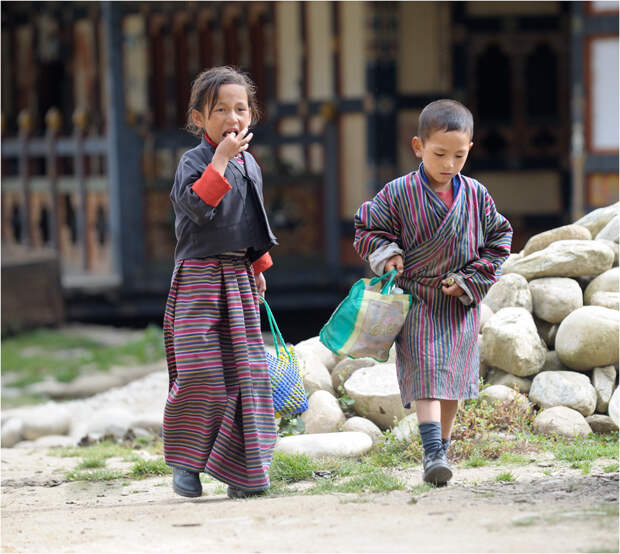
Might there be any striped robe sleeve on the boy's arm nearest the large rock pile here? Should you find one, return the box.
[454,187,512,304]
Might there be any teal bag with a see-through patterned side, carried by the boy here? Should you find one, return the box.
[319,269,411,362]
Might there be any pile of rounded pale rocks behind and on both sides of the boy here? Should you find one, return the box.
[278,204,620,455]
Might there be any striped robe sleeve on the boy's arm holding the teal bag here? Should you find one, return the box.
[353,183,402,262]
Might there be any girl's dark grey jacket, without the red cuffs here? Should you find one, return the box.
[170,137,278,262]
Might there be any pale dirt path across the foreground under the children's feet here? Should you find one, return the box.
[1,449,618,553]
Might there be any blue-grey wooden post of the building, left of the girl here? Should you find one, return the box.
[102,2,144,290]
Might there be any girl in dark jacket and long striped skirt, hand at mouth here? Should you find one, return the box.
[163,67,277,498]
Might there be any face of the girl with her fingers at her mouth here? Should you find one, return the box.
[192,84,252,144]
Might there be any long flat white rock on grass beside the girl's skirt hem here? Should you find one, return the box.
[275,432,372,458]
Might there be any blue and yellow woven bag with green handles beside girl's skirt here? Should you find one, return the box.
[261,298,308,417]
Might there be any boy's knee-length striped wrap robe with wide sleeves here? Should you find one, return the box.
[353,165,512,408]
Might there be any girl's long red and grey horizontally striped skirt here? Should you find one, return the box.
[163,256,276,490]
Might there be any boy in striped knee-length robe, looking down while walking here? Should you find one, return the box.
[353,99,512,485]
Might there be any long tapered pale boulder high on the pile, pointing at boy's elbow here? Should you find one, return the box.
[504,240,614,280]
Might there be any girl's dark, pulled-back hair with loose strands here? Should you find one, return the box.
[185,66,260,136]
